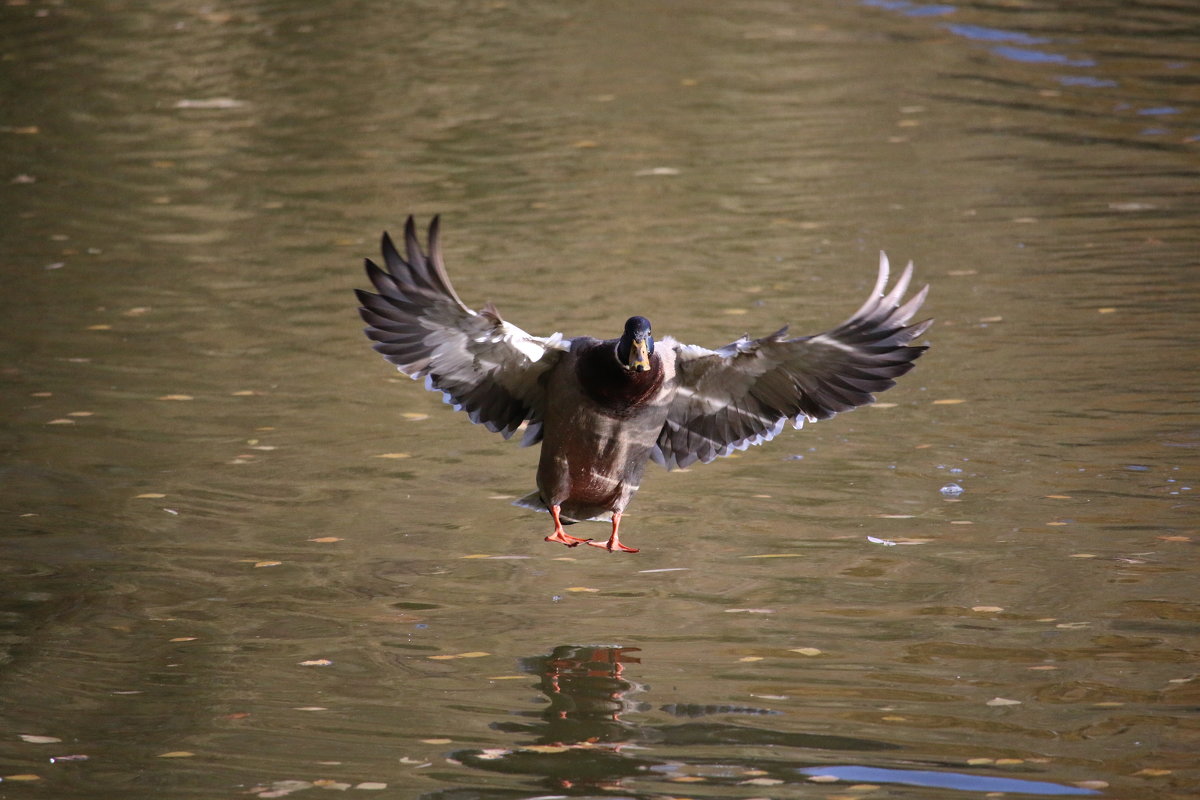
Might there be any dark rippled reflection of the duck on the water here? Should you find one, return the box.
[439,645,895,796]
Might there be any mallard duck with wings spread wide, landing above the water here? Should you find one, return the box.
[356,217,932,553]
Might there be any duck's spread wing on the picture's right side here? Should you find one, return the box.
[650,253,932,469]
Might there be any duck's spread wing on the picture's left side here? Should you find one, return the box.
[355,217,568,444]
